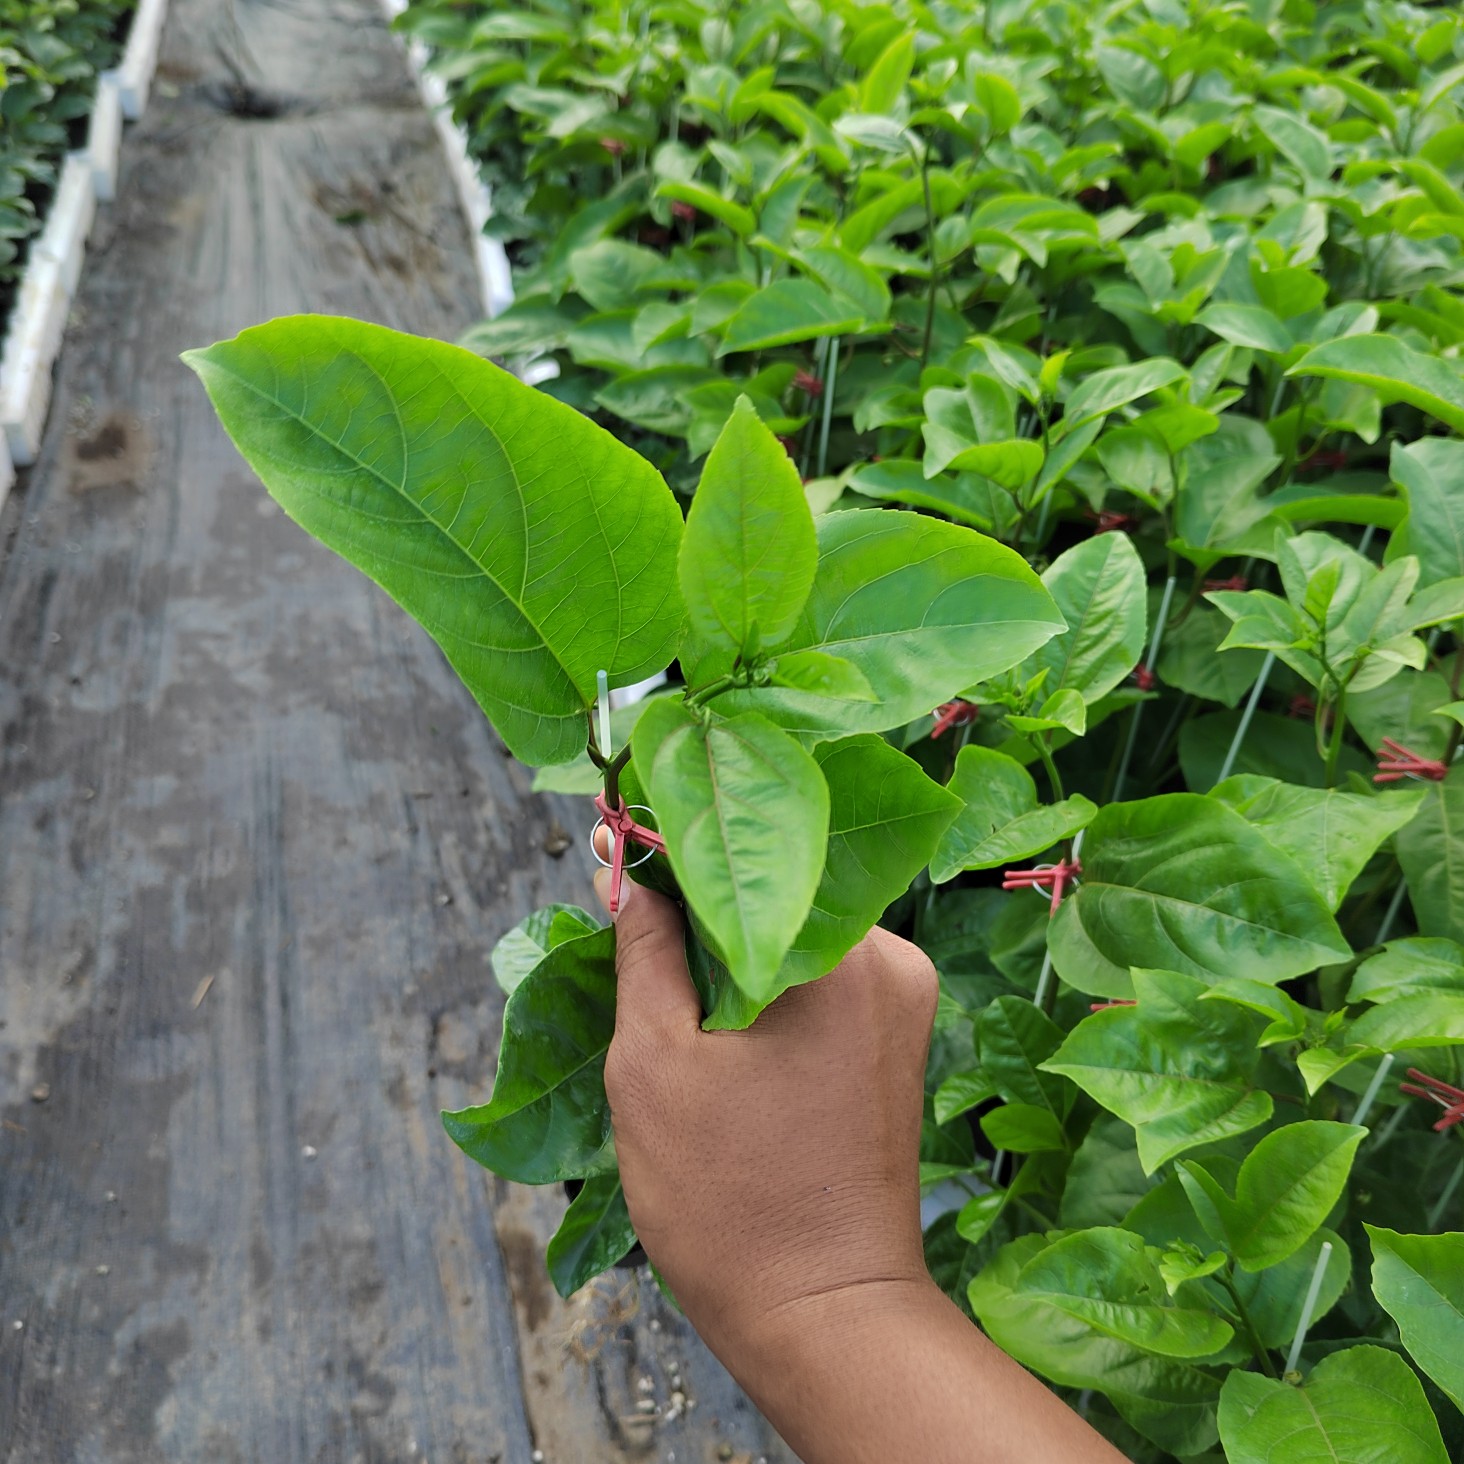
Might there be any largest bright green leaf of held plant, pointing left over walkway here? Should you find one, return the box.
[186,316,681,764]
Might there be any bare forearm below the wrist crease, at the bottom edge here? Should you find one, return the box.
[709,1281,1123,1464]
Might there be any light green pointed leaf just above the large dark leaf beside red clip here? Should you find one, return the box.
[1211,774,1423,912]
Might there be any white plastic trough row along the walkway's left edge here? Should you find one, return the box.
[0,0,167,504]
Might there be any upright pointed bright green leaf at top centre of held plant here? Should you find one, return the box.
[678,397,818,687]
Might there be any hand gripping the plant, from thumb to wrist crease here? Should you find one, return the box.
[597,871,937,1370]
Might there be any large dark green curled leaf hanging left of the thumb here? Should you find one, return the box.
[442,925,615,1184]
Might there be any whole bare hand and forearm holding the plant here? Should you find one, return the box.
[597,854,1123,1464]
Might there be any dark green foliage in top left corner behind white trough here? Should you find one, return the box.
[0,0,133,294]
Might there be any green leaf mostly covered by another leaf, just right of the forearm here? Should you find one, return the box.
[969,1236,1218,1454]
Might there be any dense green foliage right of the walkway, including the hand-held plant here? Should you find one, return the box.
[193,0,1464,1464]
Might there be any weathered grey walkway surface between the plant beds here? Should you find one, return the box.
[0,0,788,1464]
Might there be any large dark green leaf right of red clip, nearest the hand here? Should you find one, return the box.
[1048,793,1350,997]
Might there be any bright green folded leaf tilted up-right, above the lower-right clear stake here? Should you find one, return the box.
[1180,1118,1367,1271]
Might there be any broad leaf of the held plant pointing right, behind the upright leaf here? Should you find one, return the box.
[716,511,1063,736]
